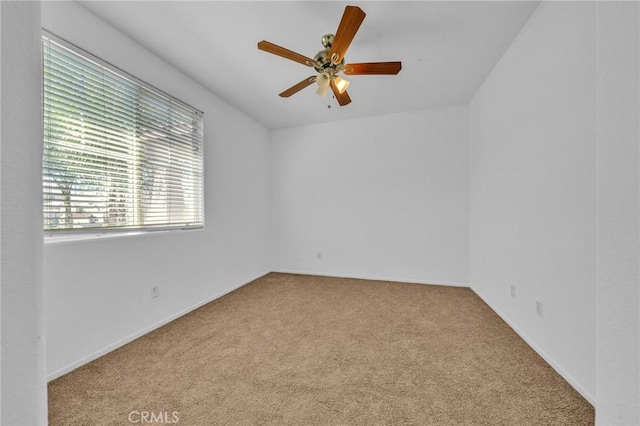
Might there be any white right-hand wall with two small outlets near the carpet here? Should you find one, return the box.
[469,2,596,403]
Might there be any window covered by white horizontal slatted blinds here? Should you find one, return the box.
[43,34,204,232]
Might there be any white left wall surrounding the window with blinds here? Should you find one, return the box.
[42,2,269,378]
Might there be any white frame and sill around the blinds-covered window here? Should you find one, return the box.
[40,28,206,242]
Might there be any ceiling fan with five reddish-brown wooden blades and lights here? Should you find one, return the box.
[258,6,402,106]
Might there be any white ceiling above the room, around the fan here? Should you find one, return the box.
[81,1,539,129]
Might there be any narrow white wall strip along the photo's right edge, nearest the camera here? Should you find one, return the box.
[596,2,640,425]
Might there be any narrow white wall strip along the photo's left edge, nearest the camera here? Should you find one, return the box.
[0,2,47,426]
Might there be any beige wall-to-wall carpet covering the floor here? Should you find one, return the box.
[49,274,594,426]
